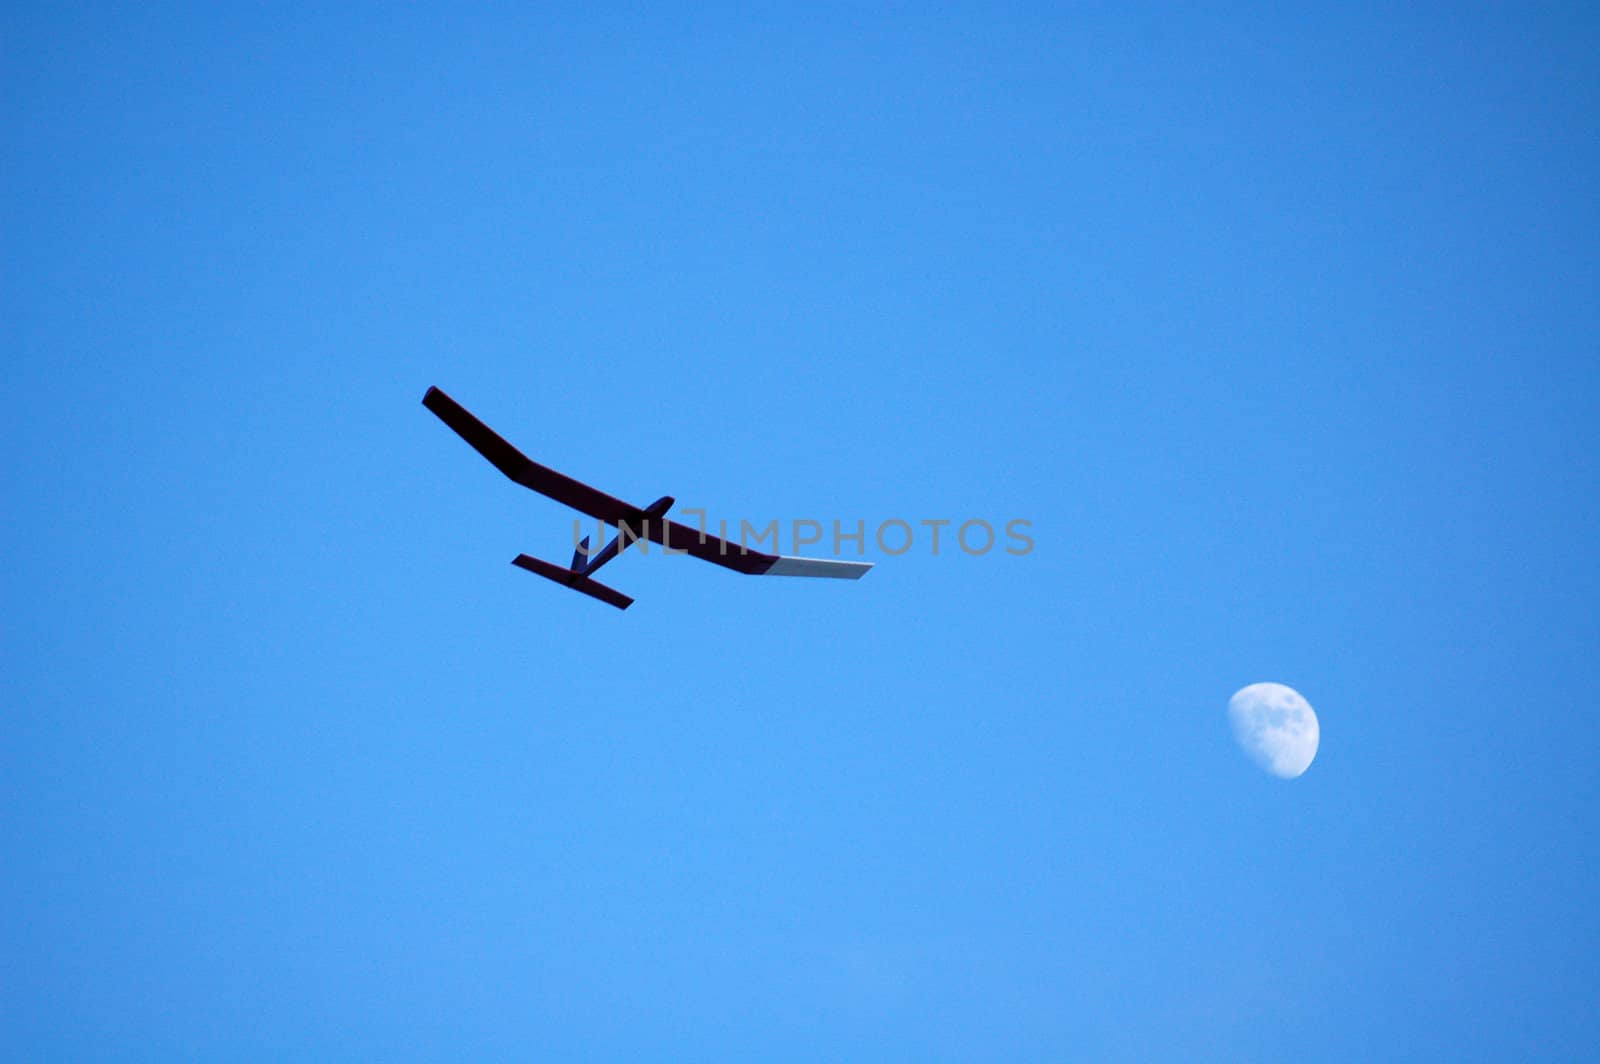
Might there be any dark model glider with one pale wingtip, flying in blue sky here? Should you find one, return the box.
[422,387,872,610]
